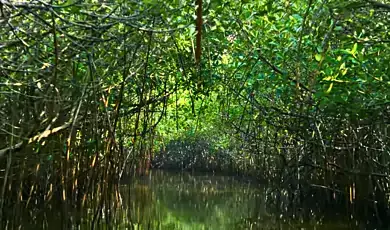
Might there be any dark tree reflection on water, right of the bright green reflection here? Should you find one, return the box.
[236,188,356,230]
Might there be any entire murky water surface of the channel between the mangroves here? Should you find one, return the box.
[4,170,359,229]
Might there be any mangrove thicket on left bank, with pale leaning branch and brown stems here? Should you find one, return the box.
[0,0,192,226]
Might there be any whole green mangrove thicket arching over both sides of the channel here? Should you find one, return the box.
[0,0,390,228]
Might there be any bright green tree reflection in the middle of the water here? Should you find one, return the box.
[121,171,266,229]
